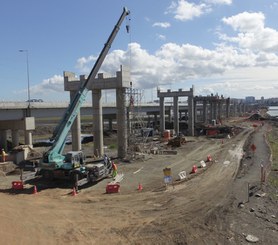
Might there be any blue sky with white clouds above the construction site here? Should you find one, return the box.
[0,0,278,102]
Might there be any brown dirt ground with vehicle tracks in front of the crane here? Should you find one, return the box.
[0,116,278,245]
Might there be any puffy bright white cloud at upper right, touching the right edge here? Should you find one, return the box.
[220,12,278,52]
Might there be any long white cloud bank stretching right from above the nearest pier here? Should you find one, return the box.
[74,39,278,97]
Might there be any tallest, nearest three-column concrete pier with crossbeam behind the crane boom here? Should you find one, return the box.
[64,66,131,158]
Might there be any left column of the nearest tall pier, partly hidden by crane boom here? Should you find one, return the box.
[70,91,82,151]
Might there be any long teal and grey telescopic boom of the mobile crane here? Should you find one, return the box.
[41,8,130,169]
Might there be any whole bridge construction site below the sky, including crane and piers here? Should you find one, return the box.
[0,8,278,245]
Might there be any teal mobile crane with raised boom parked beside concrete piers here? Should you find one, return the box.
[39,8,130,189]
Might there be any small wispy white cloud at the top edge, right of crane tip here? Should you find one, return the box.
[168,0,211,21]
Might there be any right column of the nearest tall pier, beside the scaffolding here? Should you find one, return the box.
[116,88,127,158]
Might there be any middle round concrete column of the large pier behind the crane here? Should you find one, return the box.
[92,89,104,156]
